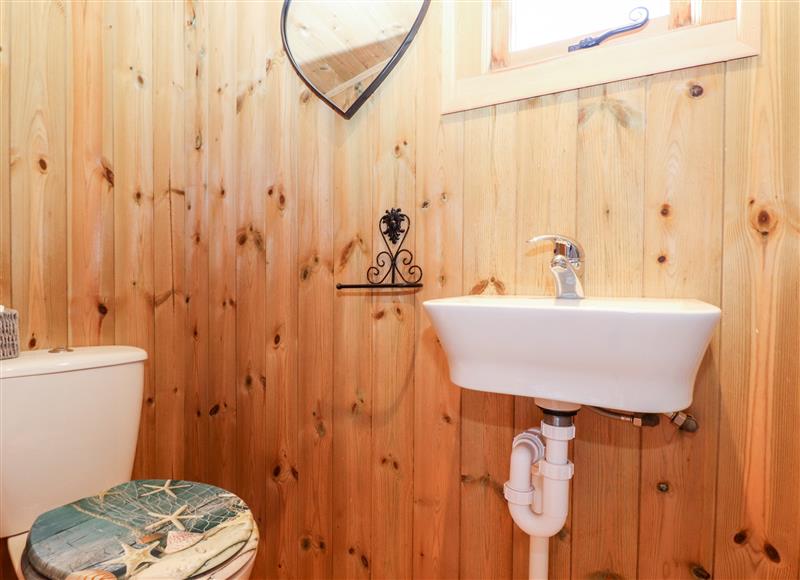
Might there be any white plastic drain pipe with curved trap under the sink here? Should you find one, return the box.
[503,418,575,580]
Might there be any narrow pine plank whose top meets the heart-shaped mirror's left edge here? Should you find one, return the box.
[264,10,301,578]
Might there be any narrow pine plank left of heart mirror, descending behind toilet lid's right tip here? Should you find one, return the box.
[236,4,272,578]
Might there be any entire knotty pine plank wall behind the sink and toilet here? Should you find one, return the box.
[0,0,800,578]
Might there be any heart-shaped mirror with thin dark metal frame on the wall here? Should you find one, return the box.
[281,0,430,119]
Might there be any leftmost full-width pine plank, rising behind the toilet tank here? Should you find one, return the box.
[9,2,67,349]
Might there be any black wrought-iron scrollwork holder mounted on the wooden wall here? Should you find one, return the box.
[336,208,422,290]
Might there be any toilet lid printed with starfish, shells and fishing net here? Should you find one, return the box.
[26,479,258,580]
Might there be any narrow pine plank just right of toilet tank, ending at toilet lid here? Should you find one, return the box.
[152,0,186,478]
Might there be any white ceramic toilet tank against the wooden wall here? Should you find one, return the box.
[0,346,147,538]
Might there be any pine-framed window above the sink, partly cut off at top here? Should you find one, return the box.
[441,0,761,113]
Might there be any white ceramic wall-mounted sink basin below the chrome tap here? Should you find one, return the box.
[424,296,720,413]
